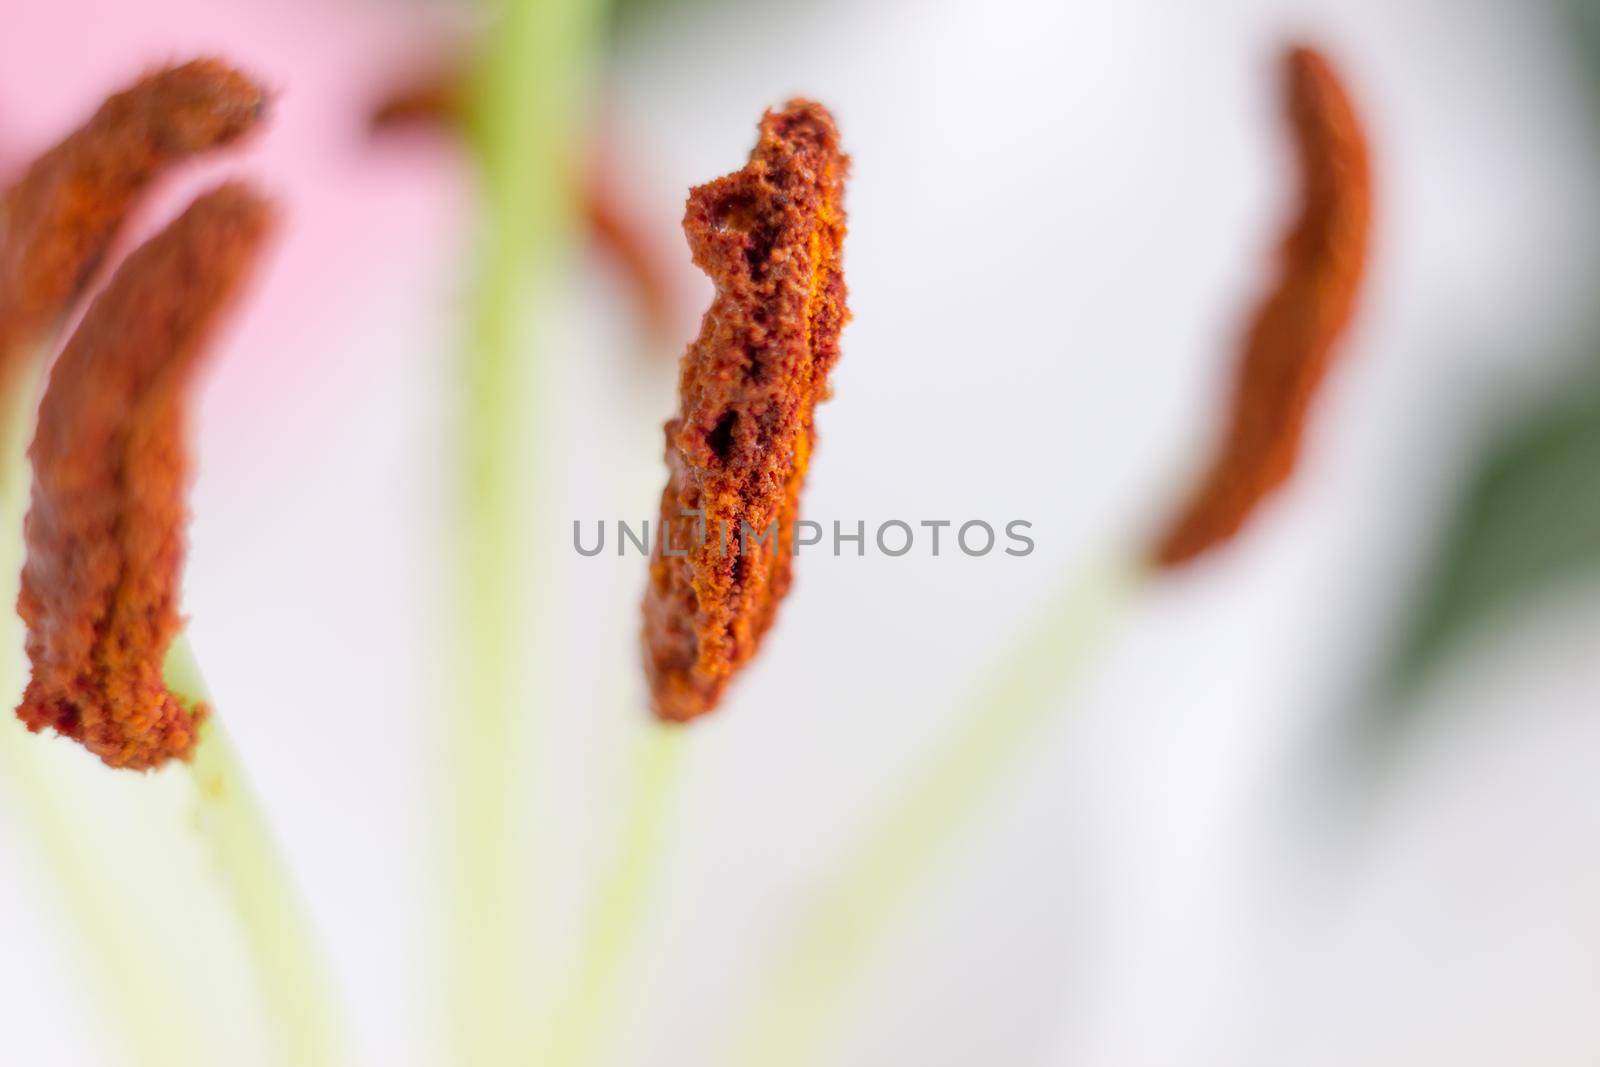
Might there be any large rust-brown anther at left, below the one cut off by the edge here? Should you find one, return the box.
[18,184,272,769]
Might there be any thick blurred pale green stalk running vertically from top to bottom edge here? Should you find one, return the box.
[451,0,600,1067]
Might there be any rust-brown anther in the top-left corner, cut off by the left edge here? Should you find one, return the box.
[0,59,267,383]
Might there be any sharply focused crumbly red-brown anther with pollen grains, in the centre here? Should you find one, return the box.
[643,101,850,721]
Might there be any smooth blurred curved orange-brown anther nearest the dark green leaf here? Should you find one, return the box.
[1152,46,1373,568]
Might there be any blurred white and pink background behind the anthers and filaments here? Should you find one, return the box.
[0,0,1600,1067]
